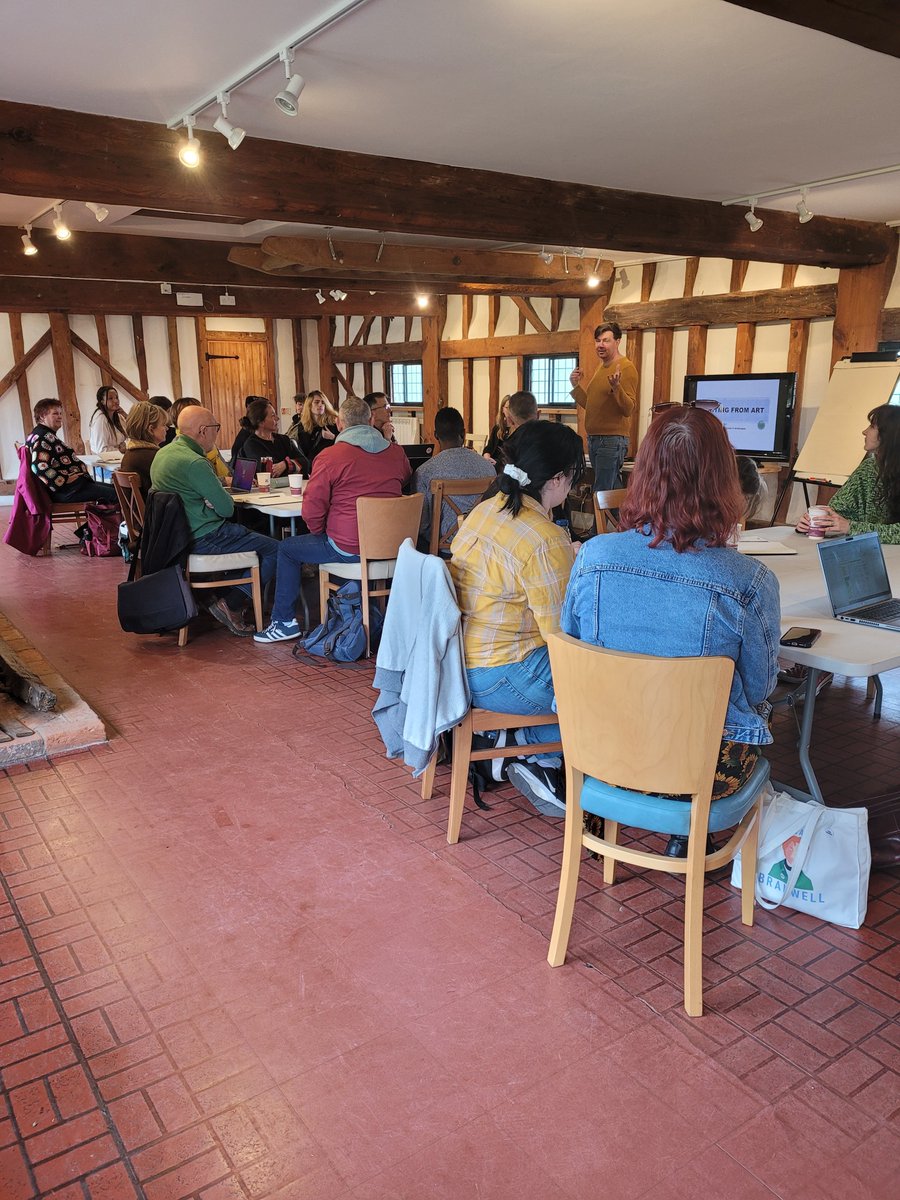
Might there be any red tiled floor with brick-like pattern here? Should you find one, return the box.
[0,528,900,1200]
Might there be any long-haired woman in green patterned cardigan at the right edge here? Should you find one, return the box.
[797,404,900,546]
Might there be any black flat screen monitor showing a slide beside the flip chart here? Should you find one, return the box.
[684,371,797,462]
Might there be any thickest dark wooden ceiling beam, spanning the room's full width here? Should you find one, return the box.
[0,101,892,266]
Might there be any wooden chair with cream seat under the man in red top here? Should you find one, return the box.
[319,492,425,658]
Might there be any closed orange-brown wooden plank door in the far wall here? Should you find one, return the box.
[198,322,277,450]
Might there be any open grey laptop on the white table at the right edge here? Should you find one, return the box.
[818,533,900,631]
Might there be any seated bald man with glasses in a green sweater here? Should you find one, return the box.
[150,407,278,637]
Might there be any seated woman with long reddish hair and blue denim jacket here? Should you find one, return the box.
[560,407,781,858]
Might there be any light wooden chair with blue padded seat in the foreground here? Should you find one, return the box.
[547,634,769,1016]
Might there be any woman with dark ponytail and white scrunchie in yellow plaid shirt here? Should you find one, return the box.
[449,421,584,815]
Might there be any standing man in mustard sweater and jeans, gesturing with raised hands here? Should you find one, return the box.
[569,322,637,492]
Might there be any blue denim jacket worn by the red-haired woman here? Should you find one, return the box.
[560,530,781,745]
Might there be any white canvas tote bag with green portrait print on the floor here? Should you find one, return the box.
[731,788,871,929]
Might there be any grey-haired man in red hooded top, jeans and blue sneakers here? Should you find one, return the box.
[253,396,410,642]
